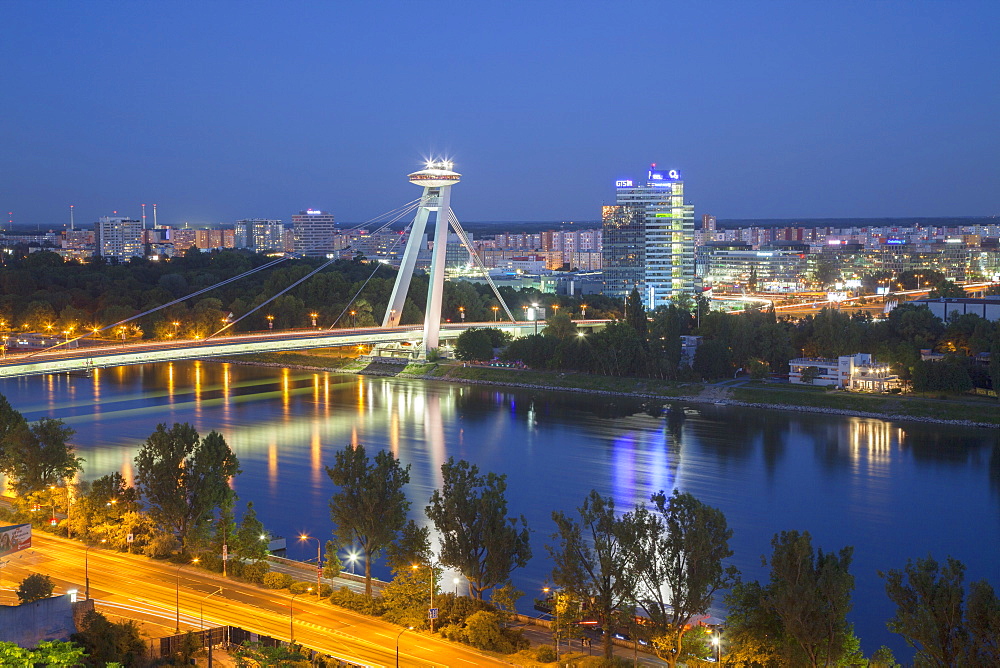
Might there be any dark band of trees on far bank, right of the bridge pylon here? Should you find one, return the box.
[456,291,1000,392]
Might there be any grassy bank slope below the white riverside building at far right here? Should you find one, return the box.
[729,384,1000,425]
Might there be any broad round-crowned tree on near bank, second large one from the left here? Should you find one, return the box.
[135,422,240,549]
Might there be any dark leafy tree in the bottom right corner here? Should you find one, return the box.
[879,556,1000,666]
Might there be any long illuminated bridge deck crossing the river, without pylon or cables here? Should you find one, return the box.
[0,320,608,378]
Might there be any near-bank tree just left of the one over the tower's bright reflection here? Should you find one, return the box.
[548,490,644,660]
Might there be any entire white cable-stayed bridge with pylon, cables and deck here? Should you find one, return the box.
[0,161,606,378]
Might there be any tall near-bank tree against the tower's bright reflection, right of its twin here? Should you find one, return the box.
[637,490,737,668]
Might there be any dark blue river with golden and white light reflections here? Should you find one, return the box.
[0,362,1000,657]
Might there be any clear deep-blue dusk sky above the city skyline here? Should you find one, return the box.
[0,0,1000,227]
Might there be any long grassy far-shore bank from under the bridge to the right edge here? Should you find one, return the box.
[217,351,1000,429]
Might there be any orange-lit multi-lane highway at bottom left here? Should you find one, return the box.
[0,531,509,666]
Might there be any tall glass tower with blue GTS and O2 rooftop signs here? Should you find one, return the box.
[602,165,695,309]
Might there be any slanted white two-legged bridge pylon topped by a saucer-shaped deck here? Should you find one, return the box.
[382,160,462,357]
